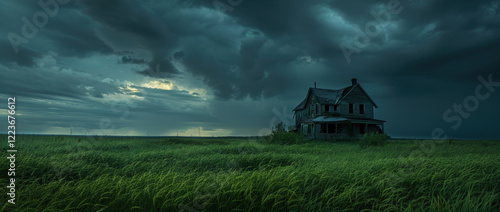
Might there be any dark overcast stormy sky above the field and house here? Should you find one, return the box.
[0,0,500,139]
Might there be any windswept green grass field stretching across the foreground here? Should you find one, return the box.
[0,136,500,212]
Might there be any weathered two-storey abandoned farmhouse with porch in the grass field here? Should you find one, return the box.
[293,78,385,139]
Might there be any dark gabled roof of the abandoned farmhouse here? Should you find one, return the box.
[293,83,378,111]
